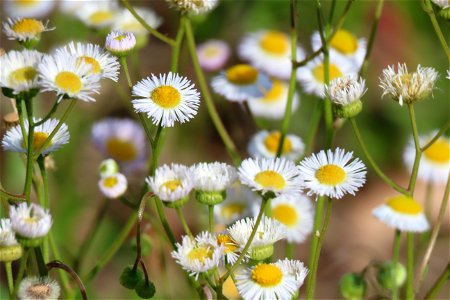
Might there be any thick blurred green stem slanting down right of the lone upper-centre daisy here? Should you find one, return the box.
[184,18,241,165]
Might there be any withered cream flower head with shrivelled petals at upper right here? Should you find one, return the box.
[380,63,439,105]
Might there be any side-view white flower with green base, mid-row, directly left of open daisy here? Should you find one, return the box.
[191,162,237,205]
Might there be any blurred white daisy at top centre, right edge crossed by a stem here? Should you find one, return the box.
[238,30,305,80]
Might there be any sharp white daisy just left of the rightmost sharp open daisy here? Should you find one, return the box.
[238,158,303,196]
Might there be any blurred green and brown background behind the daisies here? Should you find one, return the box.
[0,0,450,299]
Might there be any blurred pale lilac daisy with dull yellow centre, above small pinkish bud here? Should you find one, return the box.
[92,118,147,172]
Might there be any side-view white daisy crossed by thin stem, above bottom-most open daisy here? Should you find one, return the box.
[227,216,287,260]
